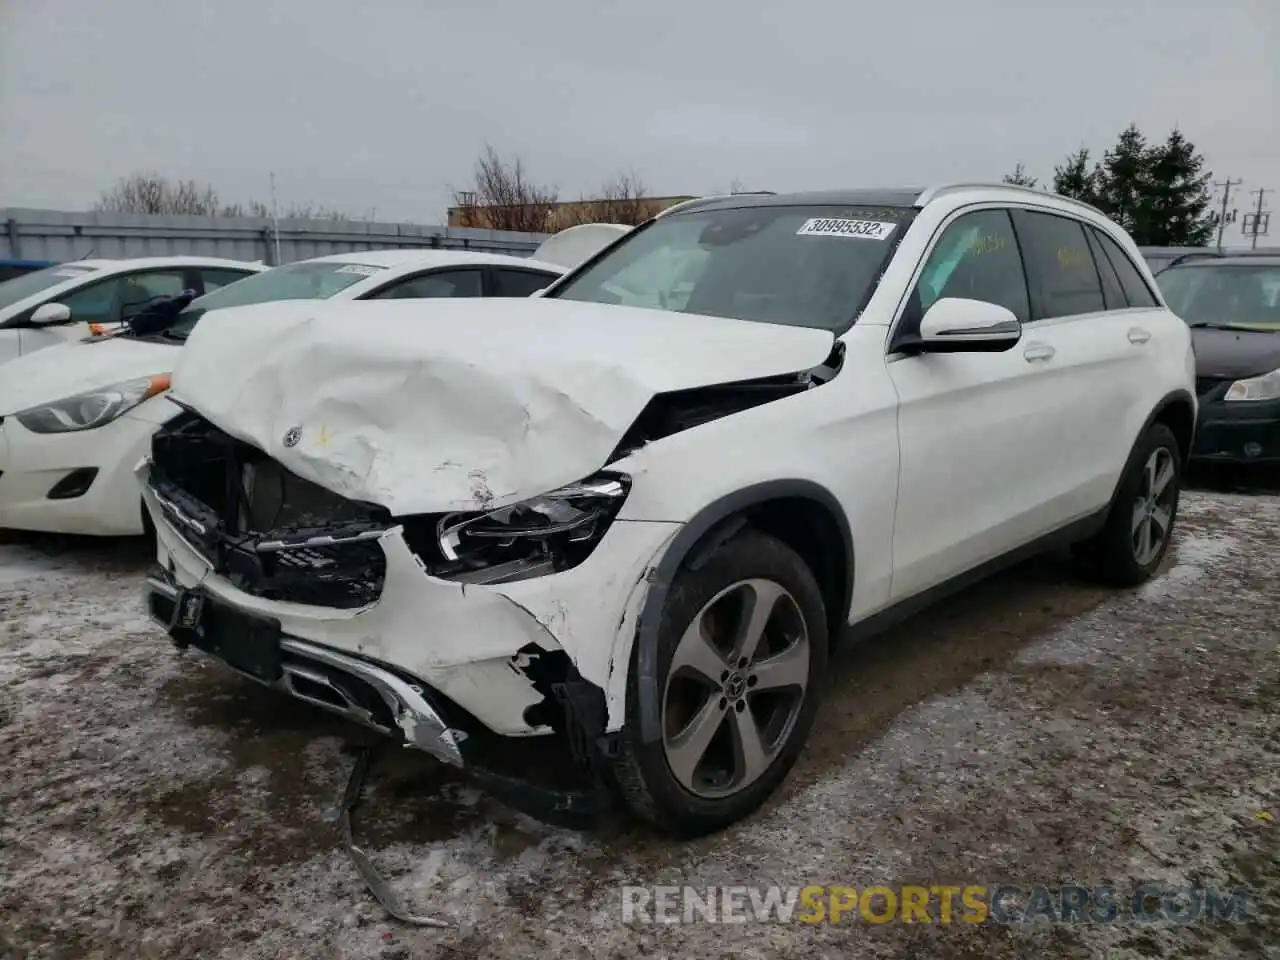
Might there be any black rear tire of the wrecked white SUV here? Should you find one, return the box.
[1074,424,1183,586]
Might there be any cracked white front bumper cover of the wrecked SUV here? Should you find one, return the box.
[138,463,680,736]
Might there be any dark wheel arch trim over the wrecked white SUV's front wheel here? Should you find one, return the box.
[634,480,855,742]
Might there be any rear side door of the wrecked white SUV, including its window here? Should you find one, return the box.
[1014,210,1152,524]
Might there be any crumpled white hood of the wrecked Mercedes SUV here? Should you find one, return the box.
[173,298,835,515]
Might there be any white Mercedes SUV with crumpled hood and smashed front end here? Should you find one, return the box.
[138,184,1196,835]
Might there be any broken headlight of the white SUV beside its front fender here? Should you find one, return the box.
[435,474,630,584]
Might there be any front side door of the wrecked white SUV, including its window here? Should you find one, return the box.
[888,207,1071,600]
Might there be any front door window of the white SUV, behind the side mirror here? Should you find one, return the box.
[910,210,1030,325]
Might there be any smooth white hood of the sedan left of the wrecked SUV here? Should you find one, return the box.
[0,337,182,416]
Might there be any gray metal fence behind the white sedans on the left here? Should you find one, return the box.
[0,207,545,265]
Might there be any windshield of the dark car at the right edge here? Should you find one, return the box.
[1156,264,1280,330]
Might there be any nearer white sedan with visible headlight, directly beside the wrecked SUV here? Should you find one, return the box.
[0,250,564,535]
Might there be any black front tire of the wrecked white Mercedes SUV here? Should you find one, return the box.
[613,527,828,837]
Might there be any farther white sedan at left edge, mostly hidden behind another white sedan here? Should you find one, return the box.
[0,256,266,366]
